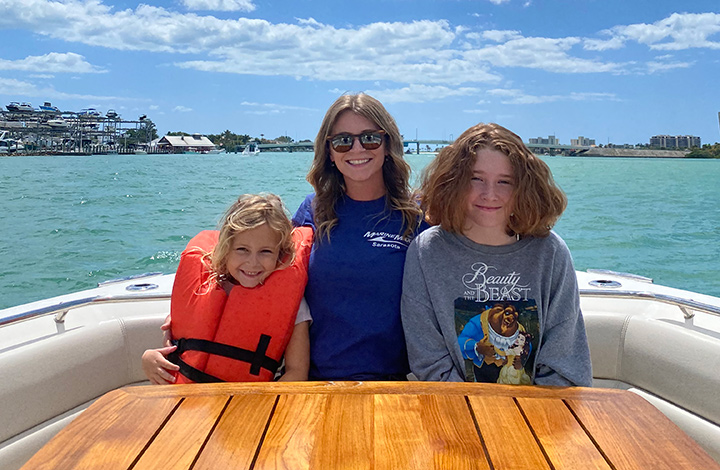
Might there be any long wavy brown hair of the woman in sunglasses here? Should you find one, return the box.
[307,93,421,240]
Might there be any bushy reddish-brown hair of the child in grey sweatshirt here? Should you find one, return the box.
[420,123,567,237]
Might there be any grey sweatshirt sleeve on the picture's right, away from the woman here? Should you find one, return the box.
[535,242,592,387]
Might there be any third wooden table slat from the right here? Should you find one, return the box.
[468,396,550,470]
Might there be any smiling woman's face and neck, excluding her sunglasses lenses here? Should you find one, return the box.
[330,111,385,201]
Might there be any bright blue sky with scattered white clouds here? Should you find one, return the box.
[0,0,720,144]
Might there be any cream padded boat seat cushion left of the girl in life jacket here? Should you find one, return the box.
[0,315,162,443]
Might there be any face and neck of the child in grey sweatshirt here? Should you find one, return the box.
[463,148,515,245]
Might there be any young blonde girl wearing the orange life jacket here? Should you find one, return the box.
[143,194,312,384]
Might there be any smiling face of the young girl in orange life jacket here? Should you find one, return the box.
[226,224,280,288]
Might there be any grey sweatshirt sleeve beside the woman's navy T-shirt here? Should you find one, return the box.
[401,242,464,382]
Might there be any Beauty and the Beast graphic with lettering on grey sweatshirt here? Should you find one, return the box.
[455,263,540,385]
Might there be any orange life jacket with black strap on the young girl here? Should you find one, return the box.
[169,227,313,383]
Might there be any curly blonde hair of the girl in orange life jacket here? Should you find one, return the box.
[203,194,295,284]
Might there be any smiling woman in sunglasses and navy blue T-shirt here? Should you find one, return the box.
[293,93,425,380]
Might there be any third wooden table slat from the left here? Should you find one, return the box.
[193,395,277,470]
